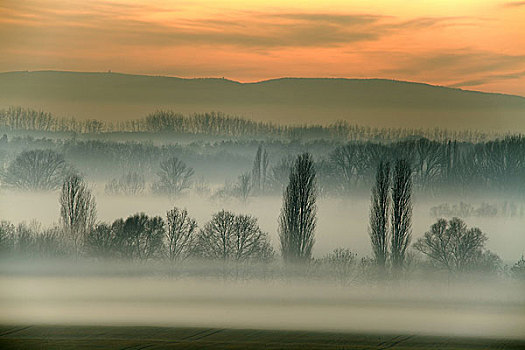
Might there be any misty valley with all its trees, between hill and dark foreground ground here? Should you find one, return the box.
[0,107,525,344]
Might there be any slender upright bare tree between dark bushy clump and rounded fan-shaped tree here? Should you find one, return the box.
[166,208,197,261]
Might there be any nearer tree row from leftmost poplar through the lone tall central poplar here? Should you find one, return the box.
[0,153,317,262]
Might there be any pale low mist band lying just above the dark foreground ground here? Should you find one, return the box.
[0,263,525,339]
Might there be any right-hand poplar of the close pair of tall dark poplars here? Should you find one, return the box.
[390,159,412,269]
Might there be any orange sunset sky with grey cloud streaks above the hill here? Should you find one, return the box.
[0,0,525,96]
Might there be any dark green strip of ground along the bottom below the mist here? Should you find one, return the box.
[0,326,525,349]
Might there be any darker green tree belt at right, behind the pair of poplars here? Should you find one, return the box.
[330,136,525,191]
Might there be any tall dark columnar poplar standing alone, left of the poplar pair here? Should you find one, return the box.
[279,153,317,262]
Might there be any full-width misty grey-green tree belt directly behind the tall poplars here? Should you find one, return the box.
[6,137,525,195]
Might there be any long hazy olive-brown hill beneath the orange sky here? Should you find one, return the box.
[0,71,525,132]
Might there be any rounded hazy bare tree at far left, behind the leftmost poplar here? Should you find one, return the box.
[3,150,68,191]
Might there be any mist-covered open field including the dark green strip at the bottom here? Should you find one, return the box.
[0,276,525,349]
